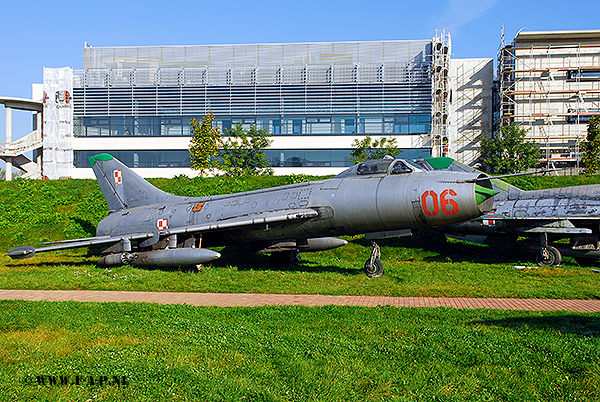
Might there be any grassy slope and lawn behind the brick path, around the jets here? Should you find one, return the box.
[0,176,600,298]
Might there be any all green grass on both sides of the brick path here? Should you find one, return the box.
[0,177,600,402]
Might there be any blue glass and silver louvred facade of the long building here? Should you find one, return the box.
[73,40,432,168]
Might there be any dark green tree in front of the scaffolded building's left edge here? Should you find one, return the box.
[480,123,540,174]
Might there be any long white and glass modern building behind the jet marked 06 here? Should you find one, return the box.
[2,31,493,178]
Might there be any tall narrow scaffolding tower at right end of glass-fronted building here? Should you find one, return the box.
[431,30,451,157]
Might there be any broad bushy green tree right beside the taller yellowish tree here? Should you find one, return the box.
[215,124,273,176]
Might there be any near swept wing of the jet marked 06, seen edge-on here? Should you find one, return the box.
[159,208,319,237]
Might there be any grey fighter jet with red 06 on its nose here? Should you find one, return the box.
[8,154,496,277]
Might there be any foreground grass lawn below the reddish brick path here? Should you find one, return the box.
[0,301,600,401]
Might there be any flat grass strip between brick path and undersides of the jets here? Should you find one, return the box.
[0,231,600,299]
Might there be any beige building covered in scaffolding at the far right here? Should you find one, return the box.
[498,30,600,166]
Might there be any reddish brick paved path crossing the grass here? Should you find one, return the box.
[0,289,600,312]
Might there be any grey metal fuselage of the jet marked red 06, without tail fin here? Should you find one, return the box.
[97,169,492,246]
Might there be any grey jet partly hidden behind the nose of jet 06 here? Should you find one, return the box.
[415,158,600,266]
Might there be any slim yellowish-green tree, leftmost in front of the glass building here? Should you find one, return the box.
[188,112,221,176]
